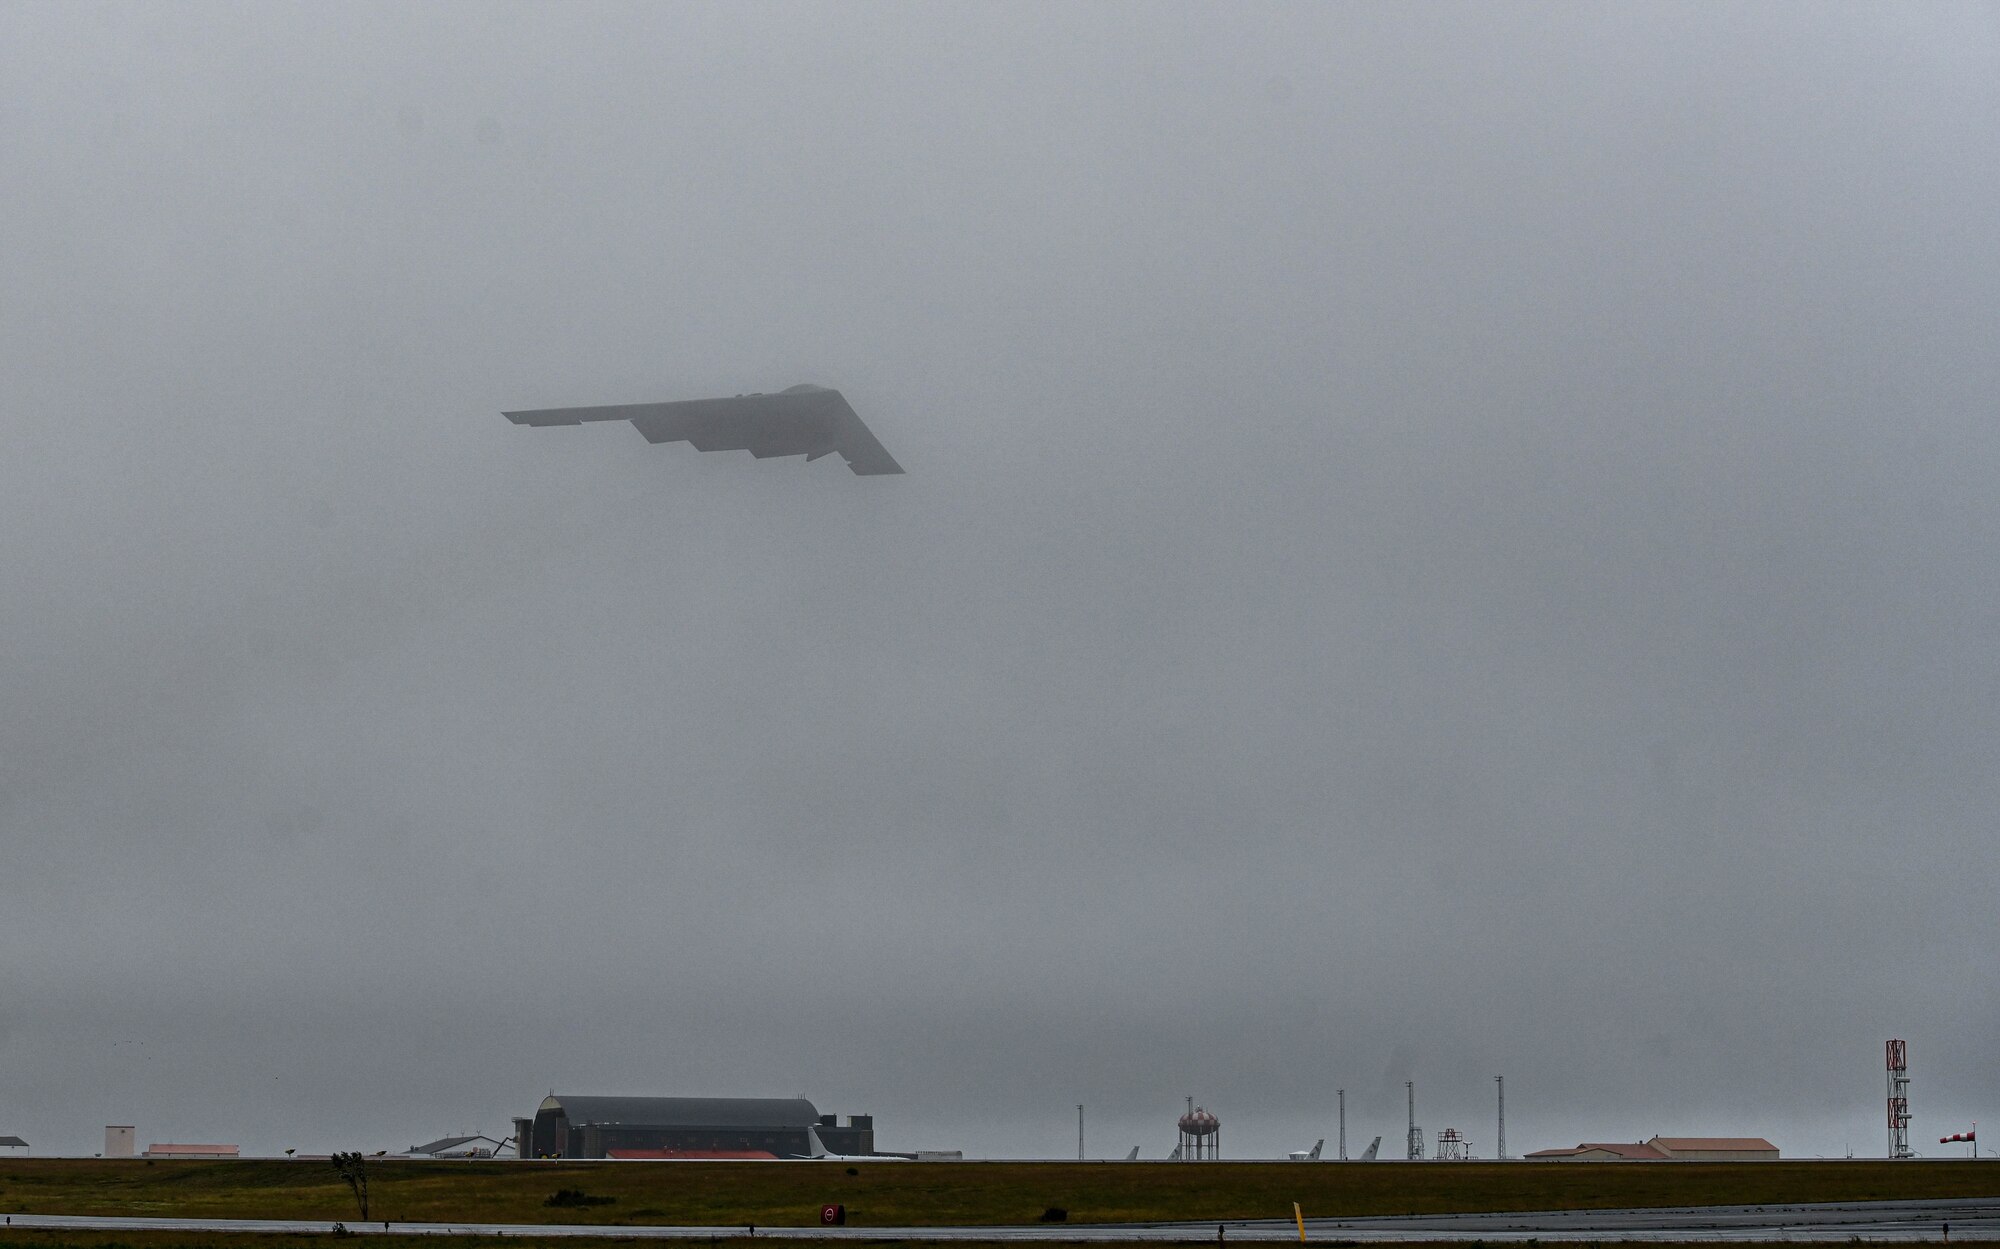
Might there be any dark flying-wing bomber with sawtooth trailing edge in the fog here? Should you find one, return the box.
[504,382,902,476]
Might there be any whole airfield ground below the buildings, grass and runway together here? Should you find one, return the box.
[0,1159,2000,1249]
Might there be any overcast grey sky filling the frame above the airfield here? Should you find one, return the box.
[0,2,2000,1157]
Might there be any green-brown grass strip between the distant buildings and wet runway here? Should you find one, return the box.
[0,1159,2000,1243]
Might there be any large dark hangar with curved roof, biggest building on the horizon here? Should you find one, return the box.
[514,1093,876,1159]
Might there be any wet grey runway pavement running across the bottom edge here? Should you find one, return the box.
[8,1199,2000,1243]
